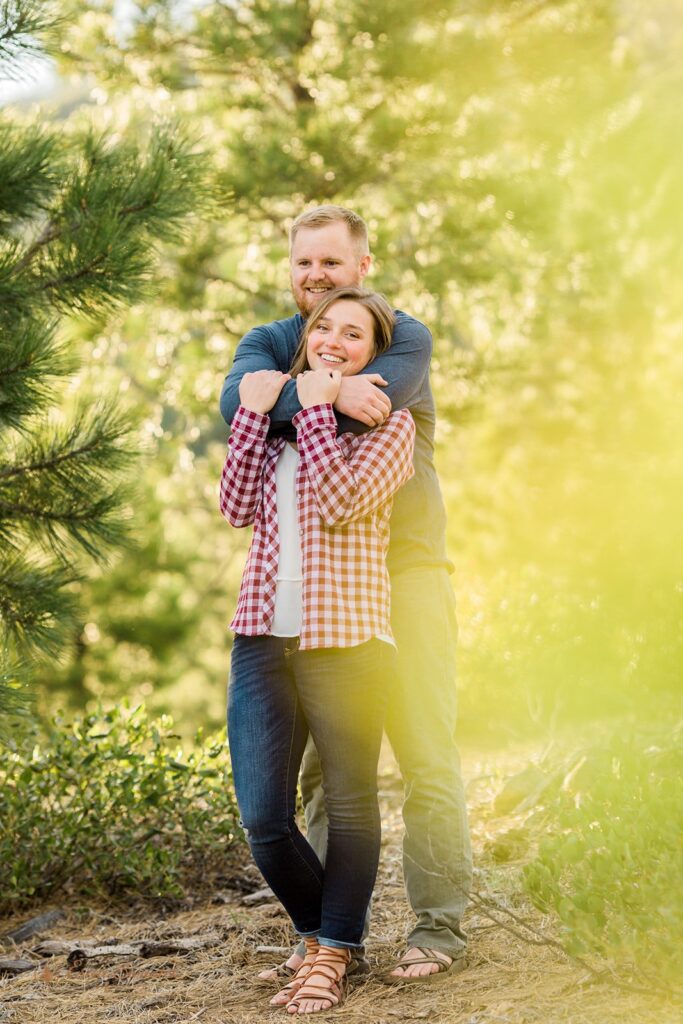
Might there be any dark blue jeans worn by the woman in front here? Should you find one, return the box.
[227,635,393,948]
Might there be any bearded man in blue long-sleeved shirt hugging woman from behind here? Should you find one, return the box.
[220,206,472,984]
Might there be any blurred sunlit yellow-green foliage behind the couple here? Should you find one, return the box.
[2,0,683,742]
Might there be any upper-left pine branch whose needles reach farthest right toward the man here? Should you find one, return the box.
[12,128,213,316]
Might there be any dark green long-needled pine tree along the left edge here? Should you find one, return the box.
[0,0,209,715]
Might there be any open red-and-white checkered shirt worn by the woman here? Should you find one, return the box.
[220,404,415,650]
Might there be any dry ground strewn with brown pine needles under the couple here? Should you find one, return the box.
[0,756,680,1024]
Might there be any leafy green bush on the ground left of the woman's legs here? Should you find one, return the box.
[0,706,242,912]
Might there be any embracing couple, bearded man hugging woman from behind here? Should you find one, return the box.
[220,206,471,1014]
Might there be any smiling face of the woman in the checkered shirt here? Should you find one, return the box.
[306,299,375,377]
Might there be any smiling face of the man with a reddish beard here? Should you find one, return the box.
[290,220,370,316]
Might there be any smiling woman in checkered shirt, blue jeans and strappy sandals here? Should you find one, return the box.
[220,288,415,1014]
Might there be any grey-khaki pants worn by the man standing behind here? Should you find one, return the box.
[301,568,472,956]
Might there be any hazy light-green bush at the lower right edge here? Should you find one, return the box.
[523,732,683,982]
